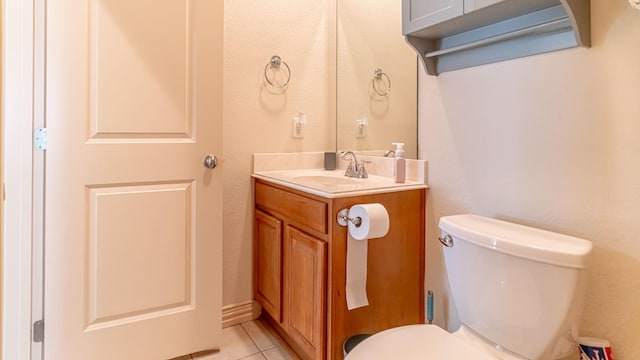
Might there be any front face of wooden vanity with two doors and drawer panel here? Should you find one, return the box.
[254,182,327,359]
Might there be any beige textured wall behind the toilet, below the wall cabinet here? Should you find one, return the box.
[419,0,640,359]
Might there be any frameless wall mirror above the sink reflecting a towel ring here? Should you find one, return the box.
[336,0,418,158]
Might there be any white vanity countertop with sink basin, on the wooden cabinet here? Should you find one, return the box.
[253,169,426,197]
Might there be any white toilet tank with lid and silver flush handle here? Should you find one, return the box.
[440,215,592,360]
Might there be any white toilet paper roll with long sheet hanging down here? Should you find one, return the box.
[345,203,389,310]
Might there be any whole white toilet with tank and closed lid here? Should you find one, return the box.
[346,215,592,360]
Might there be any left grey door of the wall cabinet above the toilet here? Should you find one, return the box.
[402,0,464,34]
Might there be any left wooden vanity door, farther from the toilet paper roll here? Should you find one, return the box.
[253,210,282,322]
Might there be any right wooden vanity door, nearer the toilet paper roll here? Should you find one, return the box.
[283,226,327,359]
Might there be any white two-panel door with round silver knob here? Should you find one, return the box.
[44,0,223,360]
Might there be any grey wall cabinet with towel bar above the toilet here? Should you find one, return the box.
[402,0,591,75]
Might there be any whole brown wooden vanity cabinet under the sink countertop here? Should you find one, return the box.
[254,178,426,360]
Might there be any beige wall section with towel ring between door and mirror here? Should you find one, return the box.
[223,0,335,305]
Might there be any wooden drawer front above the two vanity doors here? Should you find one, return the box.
[256,182,327,234]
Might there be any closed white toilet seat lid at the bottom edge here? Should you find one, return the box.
[345,325,497,360]
